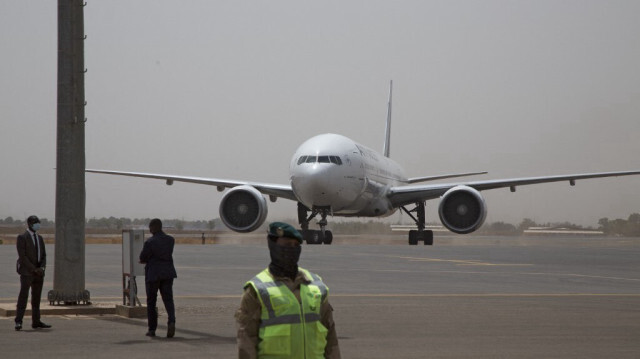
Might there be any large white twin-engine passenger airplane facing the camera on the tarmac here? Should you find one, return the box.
[86,81,640,245]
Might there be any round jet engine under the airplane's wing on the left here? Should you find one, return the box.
[220,185,267,233]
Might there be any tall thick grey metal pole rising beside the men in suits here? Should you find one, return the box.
[48,0,90,305]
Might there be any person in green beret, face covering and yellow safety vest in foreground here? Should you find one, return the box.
[235,222,340,359]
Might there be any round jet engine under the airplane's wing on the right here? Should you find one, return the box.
[438,186,487,234]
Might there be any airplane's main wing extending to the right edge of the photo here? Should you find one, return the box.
[387,171,640,207]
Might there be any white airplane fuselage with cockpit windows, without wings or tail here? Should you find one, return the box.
[289,134,407,217]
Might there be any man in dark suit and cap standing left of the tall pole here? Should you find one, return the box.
[15,216,51,330]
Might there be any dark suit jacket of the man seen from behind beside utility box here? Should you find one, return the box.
[140,232,178,282]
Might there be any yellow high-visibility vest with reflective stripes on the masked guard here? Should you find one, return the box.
[245,268,329,359]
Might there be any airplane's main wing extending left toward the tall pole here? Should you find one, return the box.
[85,169,298,201]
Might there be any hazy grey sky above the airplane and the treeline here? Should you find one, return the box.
[0,0,640,226]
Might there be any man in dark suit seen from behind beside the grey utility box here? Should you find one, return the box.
[140,218,178,338]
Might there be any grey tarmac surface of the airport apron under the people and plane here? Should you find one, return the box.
[0,236,640,358]
